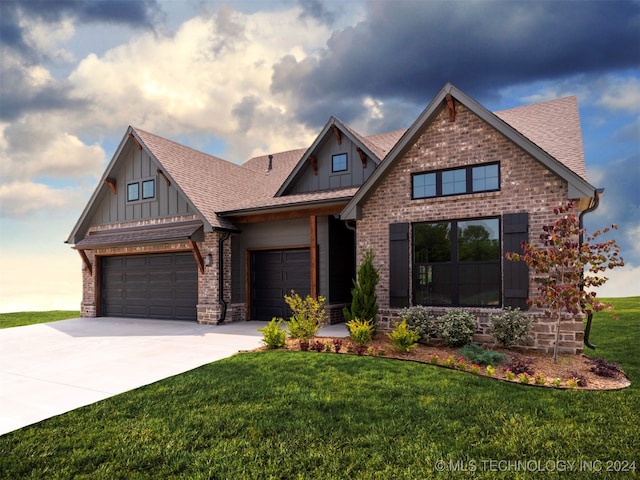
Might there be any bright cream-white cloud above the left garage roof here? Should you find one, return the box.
[68,8,330,160]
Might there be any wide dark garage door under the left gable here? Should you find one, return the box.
[100,252,198,320]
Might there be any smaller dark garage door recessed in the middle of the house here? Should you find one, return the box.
[251,248,311,320]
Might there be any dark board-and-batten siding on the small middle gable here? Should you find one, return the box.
[287,135,376,194]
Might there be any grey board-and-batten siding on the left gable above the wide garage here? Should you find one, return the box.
[91,145,194,225]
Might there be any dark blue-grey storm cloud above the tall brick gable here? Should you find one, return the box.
[272,1,640,126]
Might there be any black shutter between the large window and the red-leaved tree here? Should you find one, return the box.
[502,212,529,310]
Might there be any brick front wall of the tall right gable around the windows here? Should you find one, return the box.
[356,104,582,352]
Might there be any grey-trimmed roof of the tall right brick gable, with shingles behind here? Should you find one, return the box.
[341,83,595,220]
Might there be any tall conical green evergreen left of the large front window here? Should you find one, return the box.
[342,249,380,334]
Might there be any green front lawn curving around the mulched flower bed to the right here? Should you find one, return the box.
[0,297,640,480]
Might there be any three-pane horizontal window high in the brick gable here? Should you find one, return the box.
[412,163,500,199]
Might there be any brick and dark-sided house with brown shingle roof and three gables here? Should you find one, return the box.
[67,84,598,352]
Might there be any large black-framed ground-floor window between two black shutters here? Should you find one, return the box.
[413,218,501,306]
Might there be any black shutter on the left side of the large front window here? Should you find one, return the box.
[389,223,409,308]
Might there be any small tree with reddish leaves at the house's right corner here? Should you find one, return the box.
[506,202,624,362]
